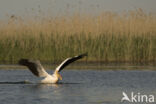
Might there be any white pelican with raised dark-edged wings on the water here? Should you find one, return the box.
[18,53,87,83]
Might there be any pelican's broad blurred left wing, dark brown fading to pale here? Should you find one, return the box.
[18,59,49,77]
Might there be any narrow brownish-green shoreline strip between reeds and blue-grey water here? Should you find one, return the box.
[0,62,156,70]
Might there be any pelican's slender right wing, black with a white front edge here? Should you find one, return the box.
[55,53,87,72]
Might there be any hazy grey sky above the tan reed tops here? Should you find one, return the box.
[0,0,156,19]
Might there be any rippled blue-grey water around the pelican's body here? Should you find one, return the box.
[0,70,156,104]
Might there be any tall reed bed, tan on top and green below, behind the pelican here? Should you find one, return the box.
[0,9,156,63]
